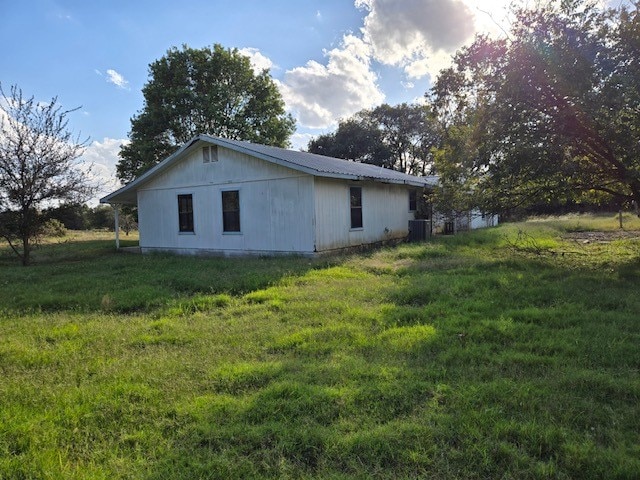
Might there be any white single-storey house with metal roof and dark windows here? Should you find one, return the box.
[100,135,433,255]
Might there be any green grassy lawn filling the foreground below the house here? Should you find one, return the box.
[0,216,640,479]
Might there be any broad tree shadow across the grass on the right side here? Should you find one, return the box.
[141,232,640,479]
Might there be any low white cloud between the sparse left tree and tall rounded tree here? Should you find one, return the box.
[80,137,129,205]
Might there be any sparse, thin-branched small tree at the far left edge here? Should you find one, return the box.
[0,85,95,265]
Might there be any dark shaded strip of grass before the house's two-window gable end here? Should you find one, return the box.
[0,240,331,313]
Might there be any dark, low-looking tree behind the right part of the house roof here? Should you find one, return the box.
[308,103,440,175]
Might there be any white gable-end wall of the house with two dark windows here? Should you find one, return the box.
[138,147,314,254]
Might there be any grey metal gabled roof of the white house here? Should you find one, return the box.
[100,135,437,203]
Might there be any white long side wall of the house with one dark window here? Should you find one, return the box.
[315,177,414,252]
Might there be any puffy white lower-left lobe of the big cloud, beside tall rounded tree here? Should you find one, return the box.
[279,35,384,128]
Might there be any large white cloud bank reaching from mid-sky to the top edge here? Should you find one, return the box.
[274,0,510,128]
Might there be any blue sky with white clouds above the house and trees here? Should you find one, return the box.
[0,0,620,204]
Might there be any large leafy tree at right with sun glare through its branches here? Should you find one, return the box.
[430,0,640,213]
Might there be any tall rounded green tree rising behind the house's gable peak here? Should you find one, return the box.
[117,44,295,182]
